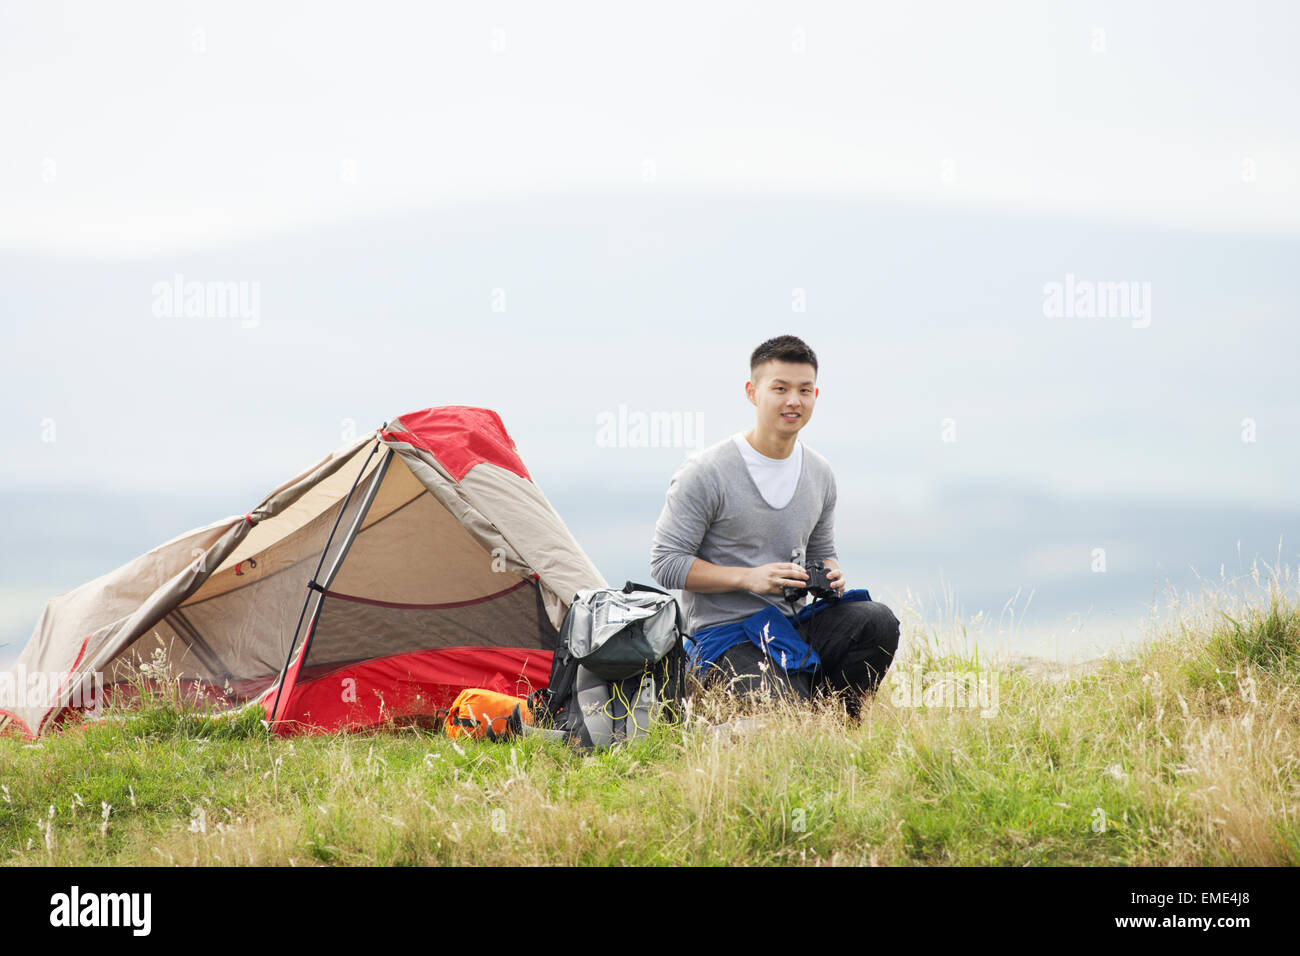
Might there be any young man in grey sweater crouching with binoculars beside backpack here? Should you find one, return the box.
[650,336,898,717]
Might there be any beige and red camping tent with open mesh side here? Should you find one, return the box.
[0,406,606,735]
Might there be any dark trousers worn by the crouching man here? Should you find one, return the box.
[706,601,898,718]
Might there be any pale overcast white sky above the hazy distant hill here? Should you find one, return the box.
[0,0,1300,256]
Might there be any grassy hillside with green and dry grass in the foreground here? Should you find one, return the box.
[0,574,1300,865]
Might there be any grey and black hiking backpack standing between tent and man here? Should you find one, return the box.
[528,581,686,748]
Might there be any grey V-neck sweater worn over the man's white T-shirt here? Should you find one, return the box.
[650,437,839,633]
